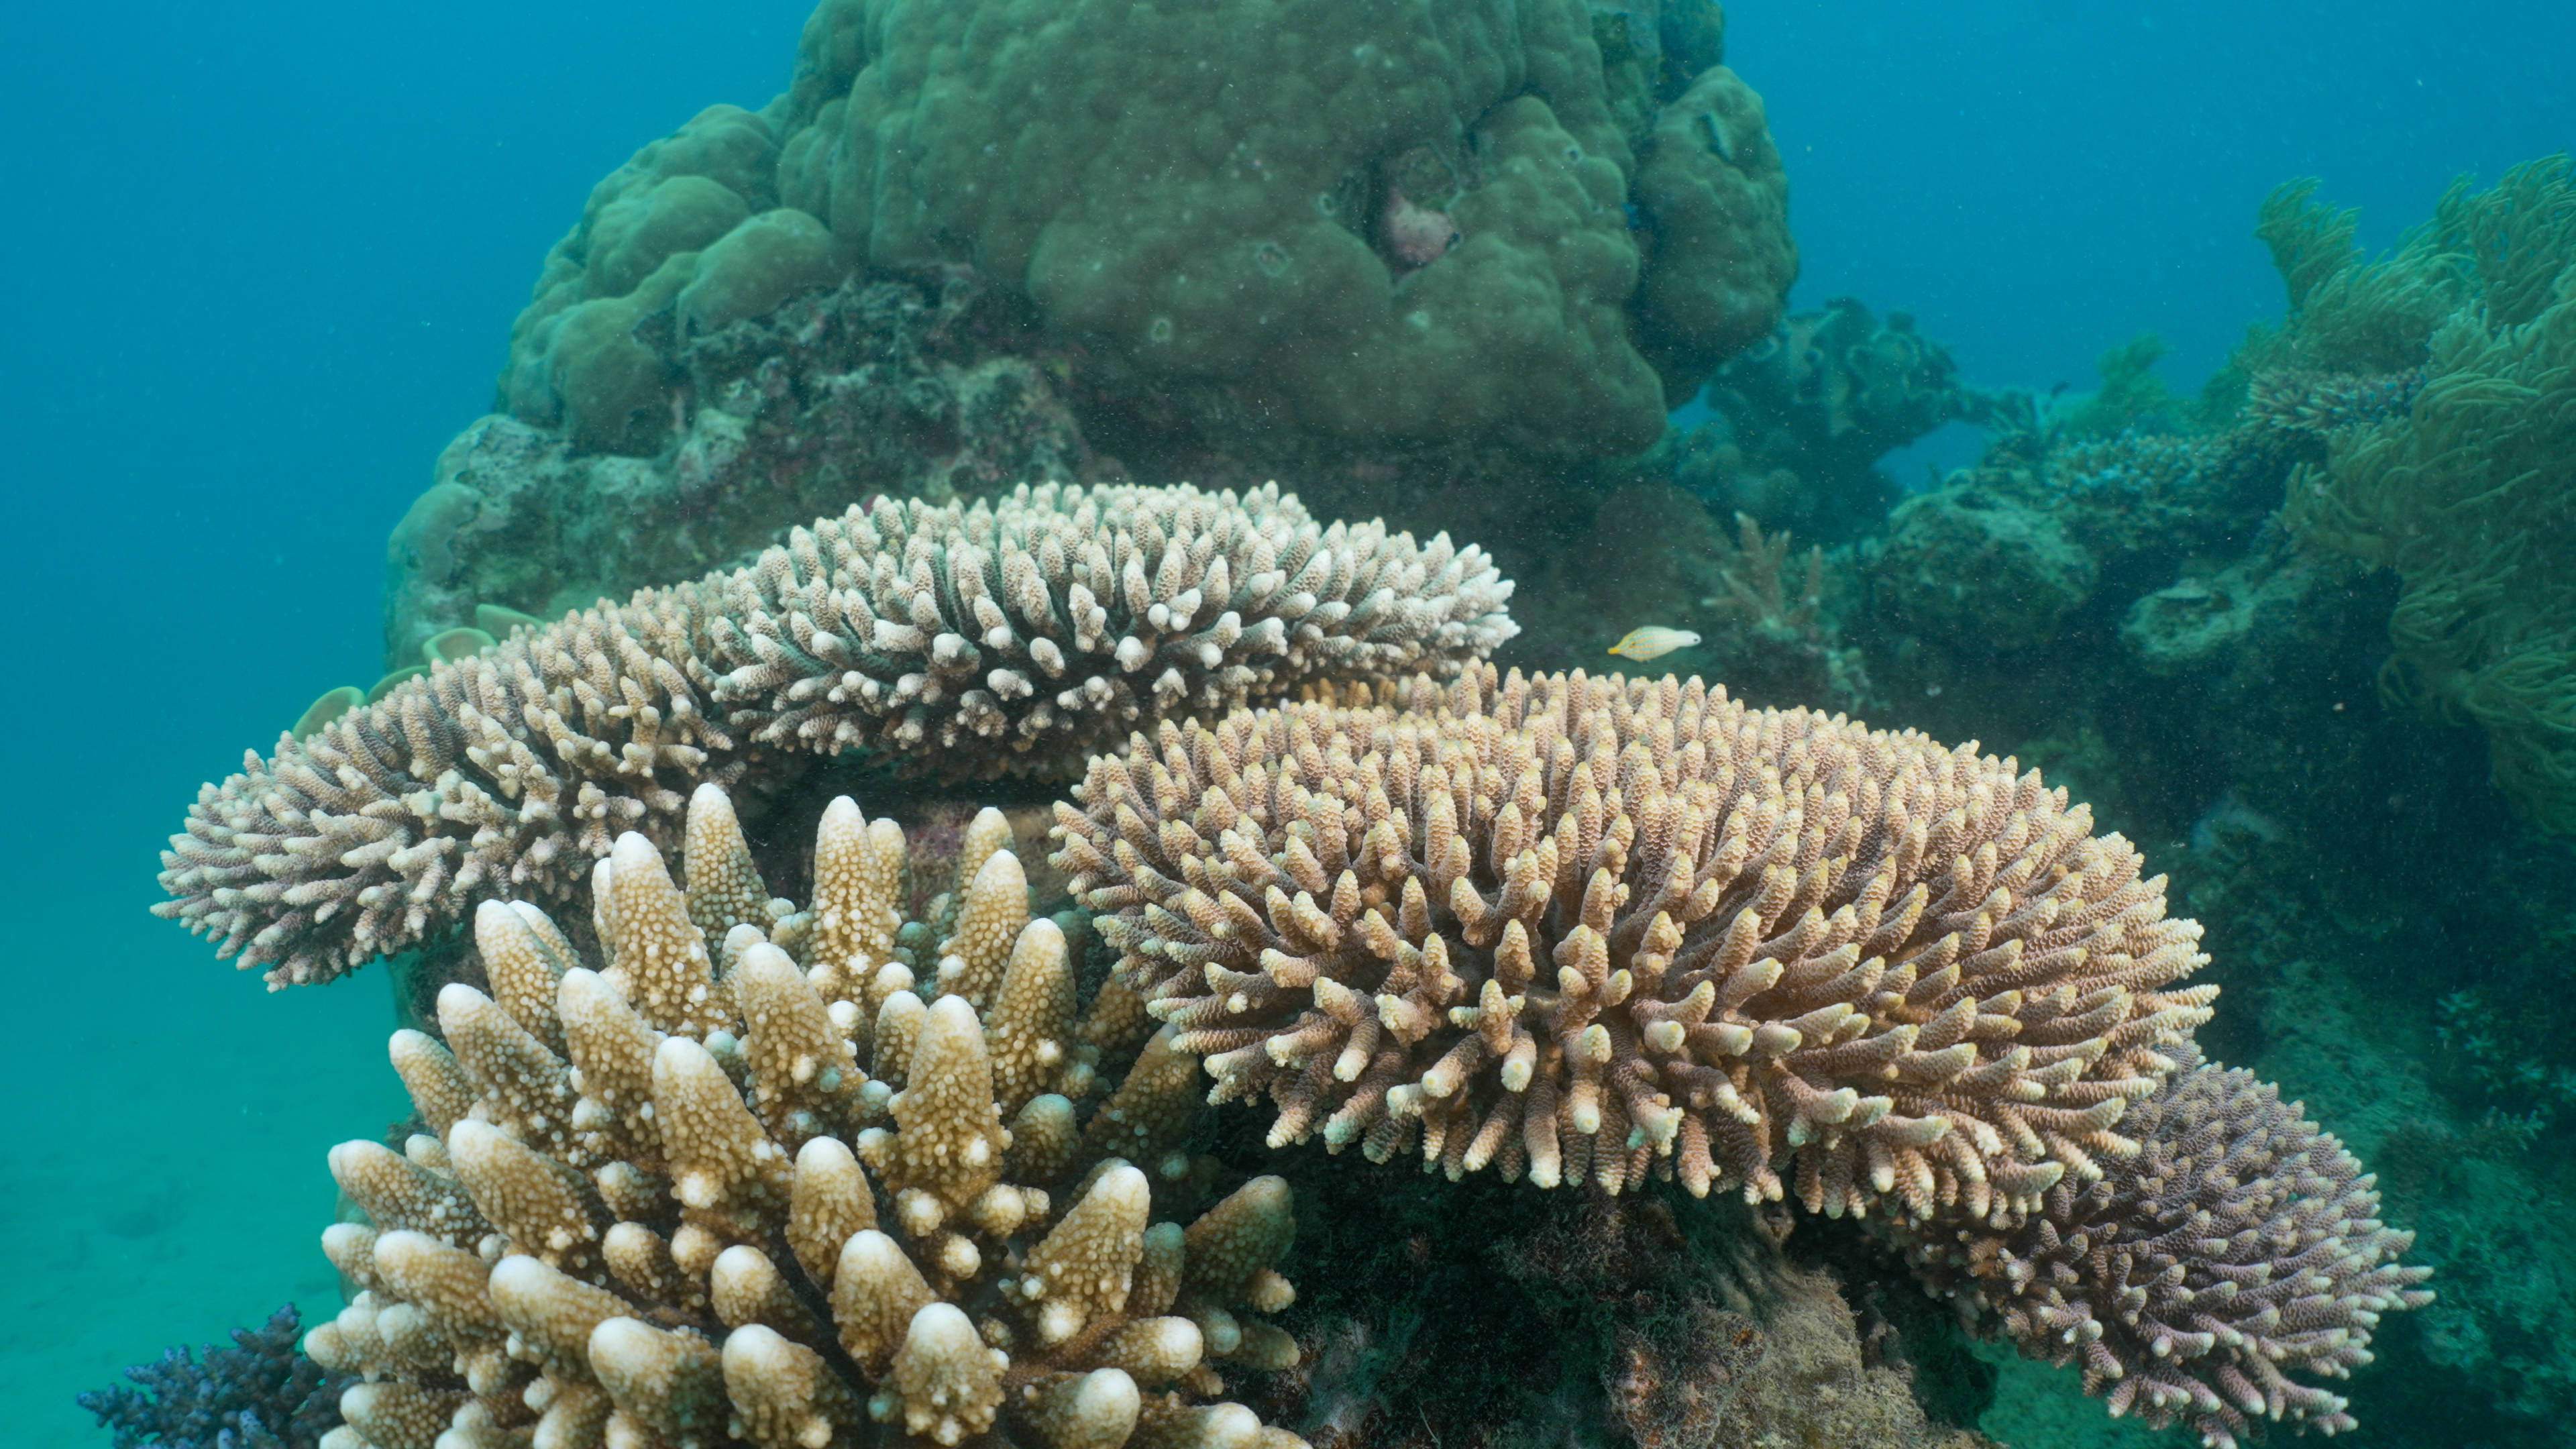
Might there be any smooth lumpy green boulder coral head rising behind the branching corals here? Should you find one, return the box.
[502,0,1795,453]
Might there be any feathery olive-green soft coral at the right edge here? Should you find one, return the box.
[2275,157,2576,833]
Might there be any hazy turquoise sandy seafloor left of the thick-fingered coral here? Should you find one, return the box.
[0,907,407,1449]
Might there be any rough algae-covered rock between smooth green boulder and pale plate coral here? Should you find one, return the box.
[384,270,1092,665]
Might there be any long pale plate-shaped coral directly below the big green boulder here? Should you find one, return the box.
[154,485,1515,987]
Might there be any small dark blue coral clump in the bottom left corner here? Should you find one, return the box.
[80,1305,347,1449]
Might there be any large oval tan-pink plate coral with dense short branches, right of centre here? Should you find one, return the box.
[1056,667,2215,1217]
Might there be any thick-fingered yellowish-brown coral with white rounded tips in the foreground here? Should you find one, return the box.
[307,786,1301,1449]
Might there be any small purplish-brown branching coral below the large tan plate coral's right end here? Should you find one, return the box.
[1909,1049,2432,1449]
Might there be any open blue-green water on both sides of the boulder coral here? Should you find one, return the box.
[0,0,2576,1444]
